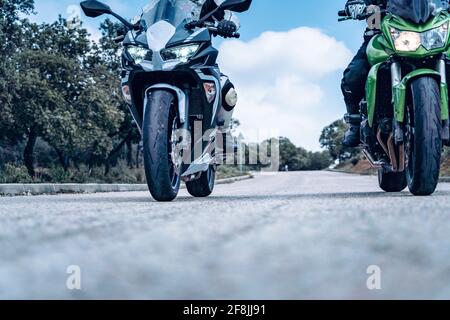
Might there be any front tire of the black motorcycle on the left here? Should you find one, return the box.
[142,91,181,201]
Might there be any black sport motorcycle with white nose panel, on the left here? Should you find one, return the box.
[81,0,251,201]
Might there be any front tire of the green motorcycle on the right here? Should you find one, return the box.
[406,77,442,196]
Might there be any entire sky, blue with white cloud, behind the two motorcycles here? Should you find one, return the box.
[31,0,365,150]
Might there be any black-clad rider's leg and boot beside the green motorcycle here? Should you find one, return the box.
[342,39,370,147]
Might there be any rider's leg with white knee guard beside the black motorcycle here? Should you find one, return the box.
[217,75,238,158]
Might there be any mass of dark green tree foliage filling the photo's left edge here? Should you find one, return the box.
[0,0,134,175]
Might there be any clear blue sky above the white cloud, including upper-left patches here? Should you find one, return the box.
[34,0,364,50]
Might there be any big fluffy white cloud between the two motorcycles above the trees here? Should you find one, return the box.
[220,27,351,150]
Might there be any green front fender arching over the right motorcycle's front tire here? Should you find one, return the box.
[392,68,449,122]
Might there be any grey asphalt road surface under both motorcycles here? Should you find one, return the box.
[0,172,450,299]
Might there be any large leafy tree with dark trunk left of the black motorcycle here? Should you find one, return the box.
[8,18,124,176]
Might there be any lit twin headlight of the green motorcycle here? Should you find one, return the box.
[390,23,448,52]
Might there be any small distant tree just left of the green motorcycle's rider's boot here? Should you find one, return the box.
[320,120,359,161]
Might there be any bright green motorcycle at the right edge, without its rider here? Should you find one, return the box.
[339,0,450,196]
